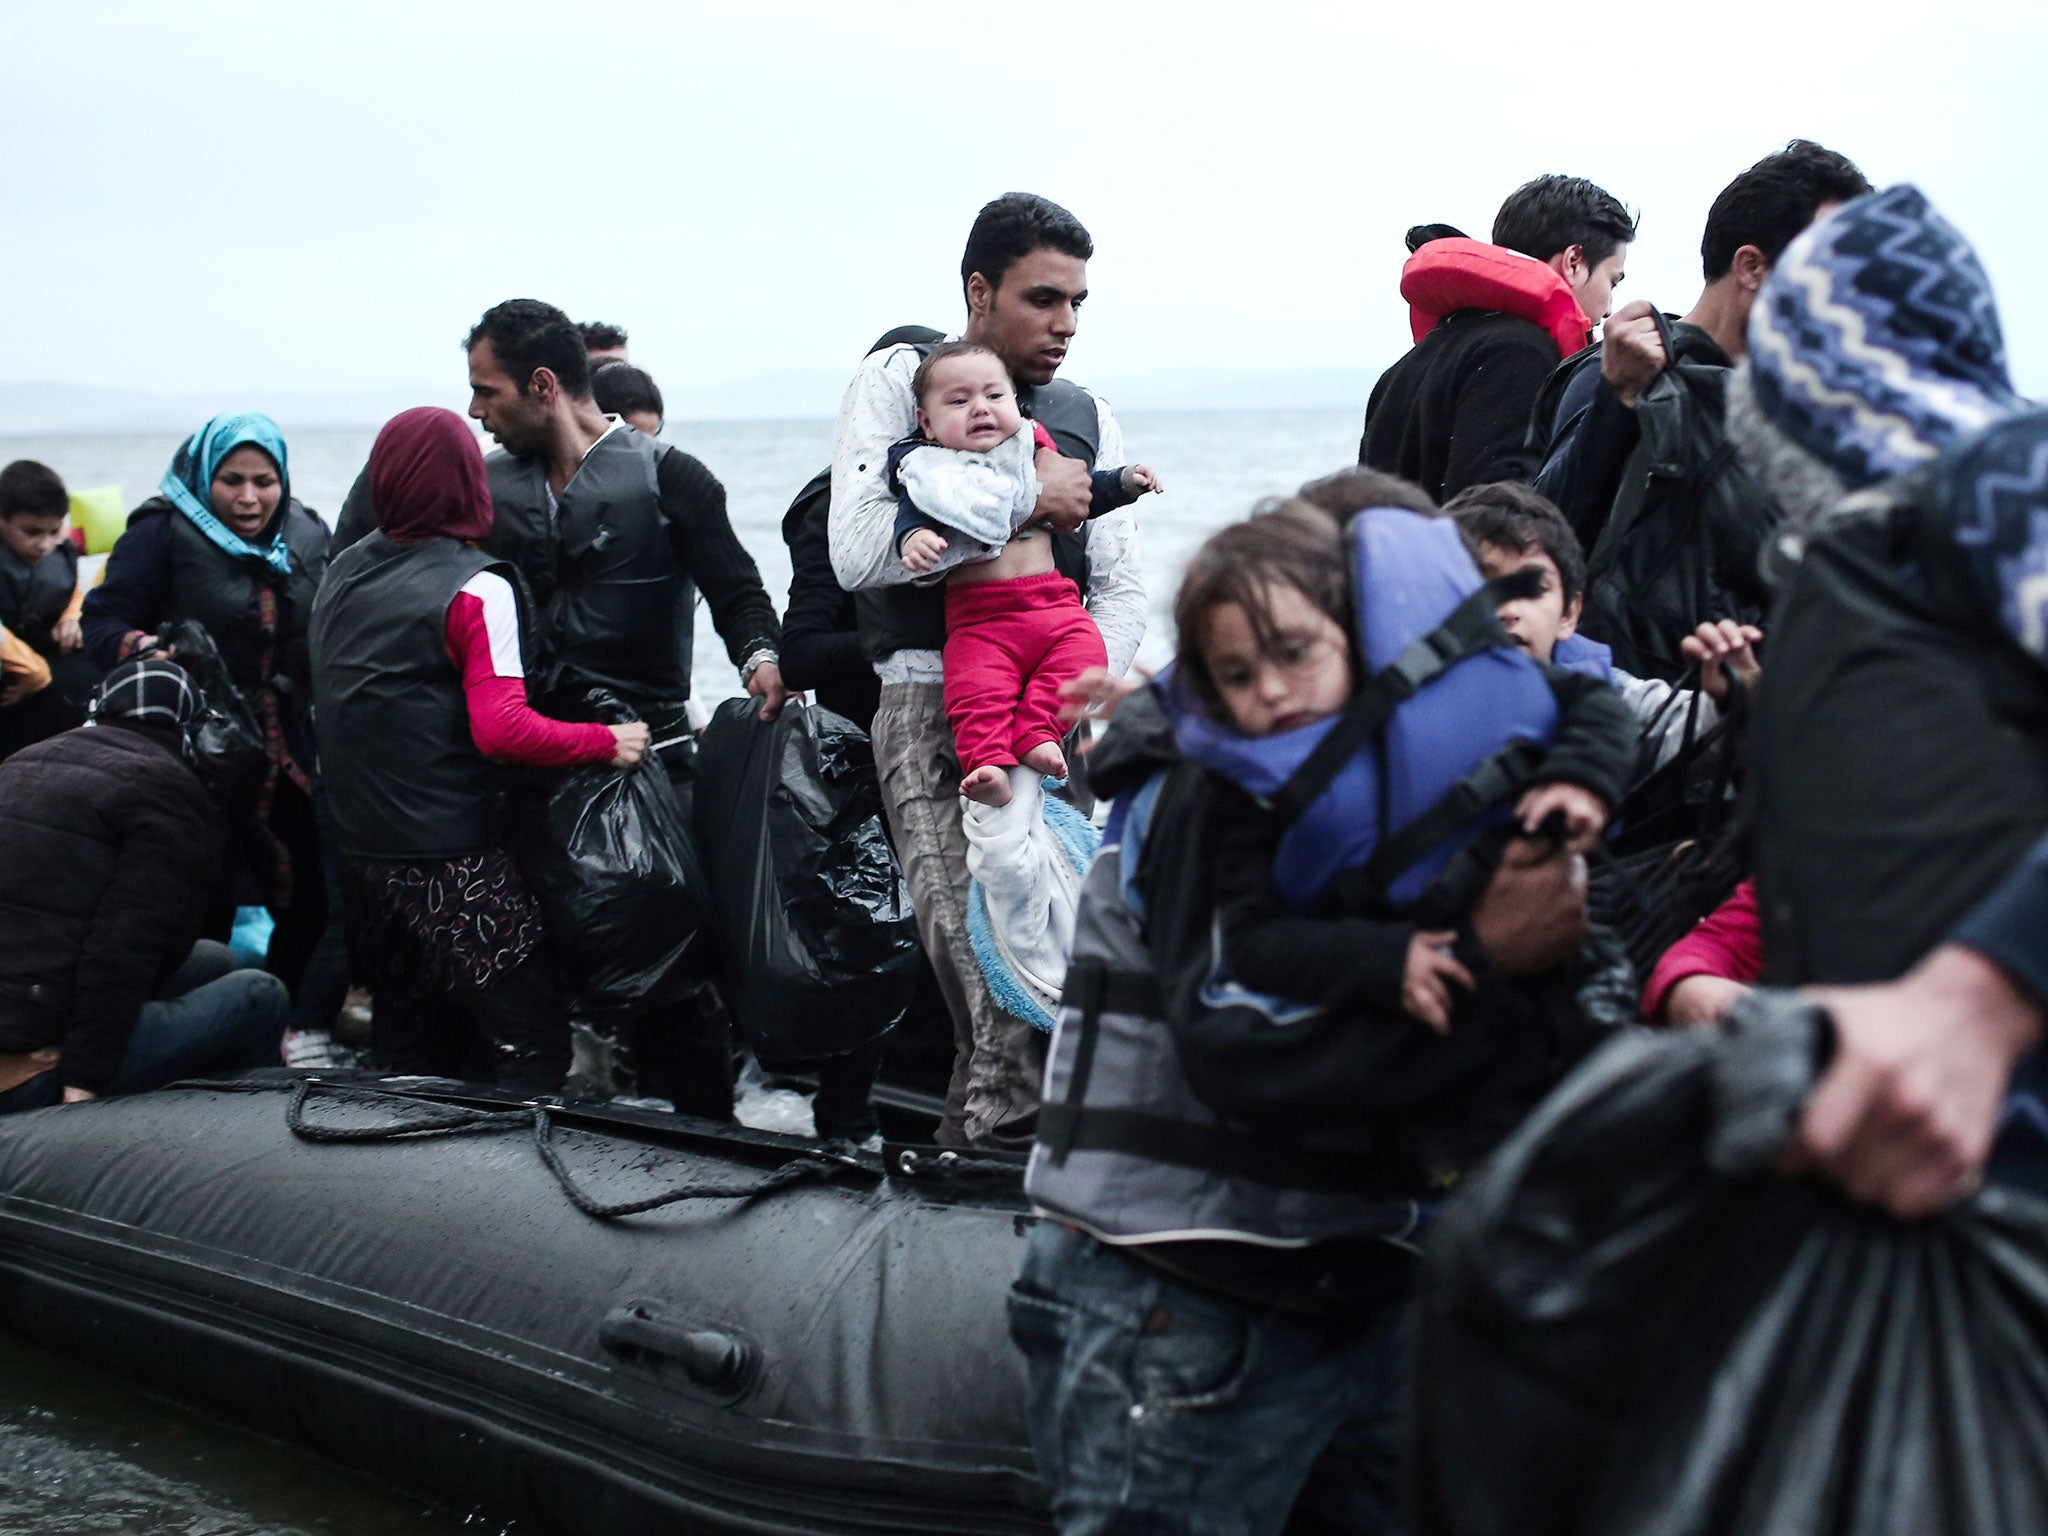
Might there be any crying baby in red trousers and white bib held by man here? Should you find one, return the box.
[889,342,1159,805]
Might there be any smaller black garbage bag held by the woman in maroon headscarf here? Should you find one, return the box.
[530,694,711,1016]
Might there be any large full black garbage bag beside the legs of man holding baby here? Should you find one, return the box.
[696,698,920,1065]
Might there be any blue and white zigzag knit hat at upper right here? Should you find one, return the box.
[1731,184,2019,512]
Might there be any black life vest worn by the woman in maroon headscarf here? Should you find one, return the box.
[311,532,526,858]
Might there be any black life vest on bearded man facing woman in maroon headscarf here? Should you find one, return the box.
[483,428,696,721]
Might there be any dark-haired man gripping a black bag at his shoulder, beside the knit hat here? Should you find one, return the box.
[1530,139,1870,680]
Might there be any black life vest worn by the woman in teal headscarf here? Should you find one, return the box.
[153,498,330,713]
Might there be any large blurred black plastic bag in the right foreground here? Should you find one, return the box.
[1413,991,2048,1536]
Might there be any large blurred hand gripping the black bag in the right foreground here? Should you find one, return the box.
[1794,944,2042,1221]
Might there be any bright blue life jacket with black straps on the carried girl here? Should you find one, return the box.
[1153,508,1559,911]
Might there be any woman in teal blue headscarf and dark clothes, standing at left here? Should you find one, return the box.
[82,412,332,1028]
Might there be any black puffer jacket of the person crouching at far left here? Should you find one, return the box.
[0,725,221,1094]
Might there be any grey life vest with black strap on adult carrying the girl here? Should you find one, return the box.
[1024,774,1417,1247]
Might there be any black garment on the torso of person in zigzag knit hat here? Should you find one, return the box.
[1753,469,2048,985]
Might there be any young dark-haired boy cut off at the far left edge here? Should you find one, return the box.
[0,459,98,758]
